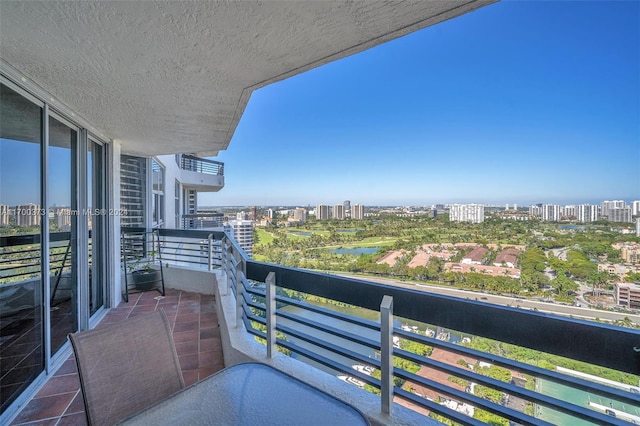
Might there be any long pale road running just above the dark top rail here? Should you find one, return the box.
[337,273,640,324]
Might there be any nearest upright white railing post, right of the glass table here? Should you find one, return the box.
[380,296,393,414]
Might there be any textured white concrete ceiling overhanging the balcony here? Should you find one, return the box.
[0,0,493,155]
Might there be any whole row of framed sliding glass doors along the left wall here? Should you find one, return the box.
[0,70,110,424]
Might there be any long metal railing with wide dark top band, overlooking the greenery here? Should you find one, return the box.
[222,238,640,425]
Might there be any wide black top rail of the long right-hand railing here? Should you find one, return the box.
[247,259,640,374]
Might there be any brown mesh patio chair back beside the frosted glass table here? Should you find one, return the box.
[69,310,185,425]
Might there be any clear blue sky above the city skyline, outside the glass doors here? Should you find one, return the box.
[199,1,640,206]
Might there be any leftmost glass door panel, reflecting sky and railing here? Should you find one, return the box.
[0,84,44,412]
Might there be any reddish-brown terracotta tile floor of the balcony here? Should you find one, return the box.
[11,289,224,426]
